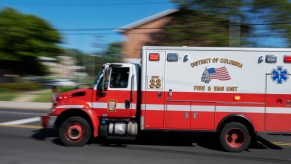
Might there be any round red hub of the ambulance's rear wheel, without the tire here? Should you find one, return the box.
[225,129,245,148]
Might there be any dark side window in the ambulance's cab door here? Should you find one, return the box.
[110,67,129,88]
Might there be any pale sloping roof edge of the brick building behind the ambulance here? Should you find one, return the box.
[116,9,178,32]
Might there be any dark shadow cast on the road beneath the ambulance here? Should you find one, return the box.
[31,129,282,151]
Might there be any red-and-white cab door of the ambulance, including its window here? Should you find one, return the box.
[93,64,137,117]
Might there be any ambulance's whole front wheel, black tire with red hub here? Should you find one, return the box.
[59,117,92,147]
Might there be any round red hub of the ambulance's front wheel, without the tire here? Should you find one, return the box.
[66,124,84,141]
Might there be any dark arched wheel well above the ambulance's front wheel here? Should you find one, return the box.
[55,109,93,129]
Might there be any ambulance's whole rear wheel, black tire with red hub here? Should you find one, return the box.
[219,122,251,152]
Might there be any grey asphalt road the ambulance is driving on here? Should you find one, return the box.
[0,109,291,164]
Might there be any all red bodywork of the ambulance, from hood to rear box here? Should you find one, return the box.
[44,89,291,136]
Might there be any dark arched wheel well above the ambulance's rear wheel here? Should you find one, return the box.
[217,115,255,136]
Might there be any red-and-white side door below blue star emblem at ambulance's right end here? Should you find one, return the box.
[265,66,291,132]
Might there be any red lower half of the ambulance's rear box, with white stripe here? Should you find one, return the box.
[142,92,291,132]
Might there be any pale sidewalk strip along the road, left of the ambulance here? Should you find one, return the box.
[0,101,52,110]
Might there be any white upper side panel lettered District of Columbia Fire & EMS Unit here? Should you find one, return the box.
[142,47,291,94]
